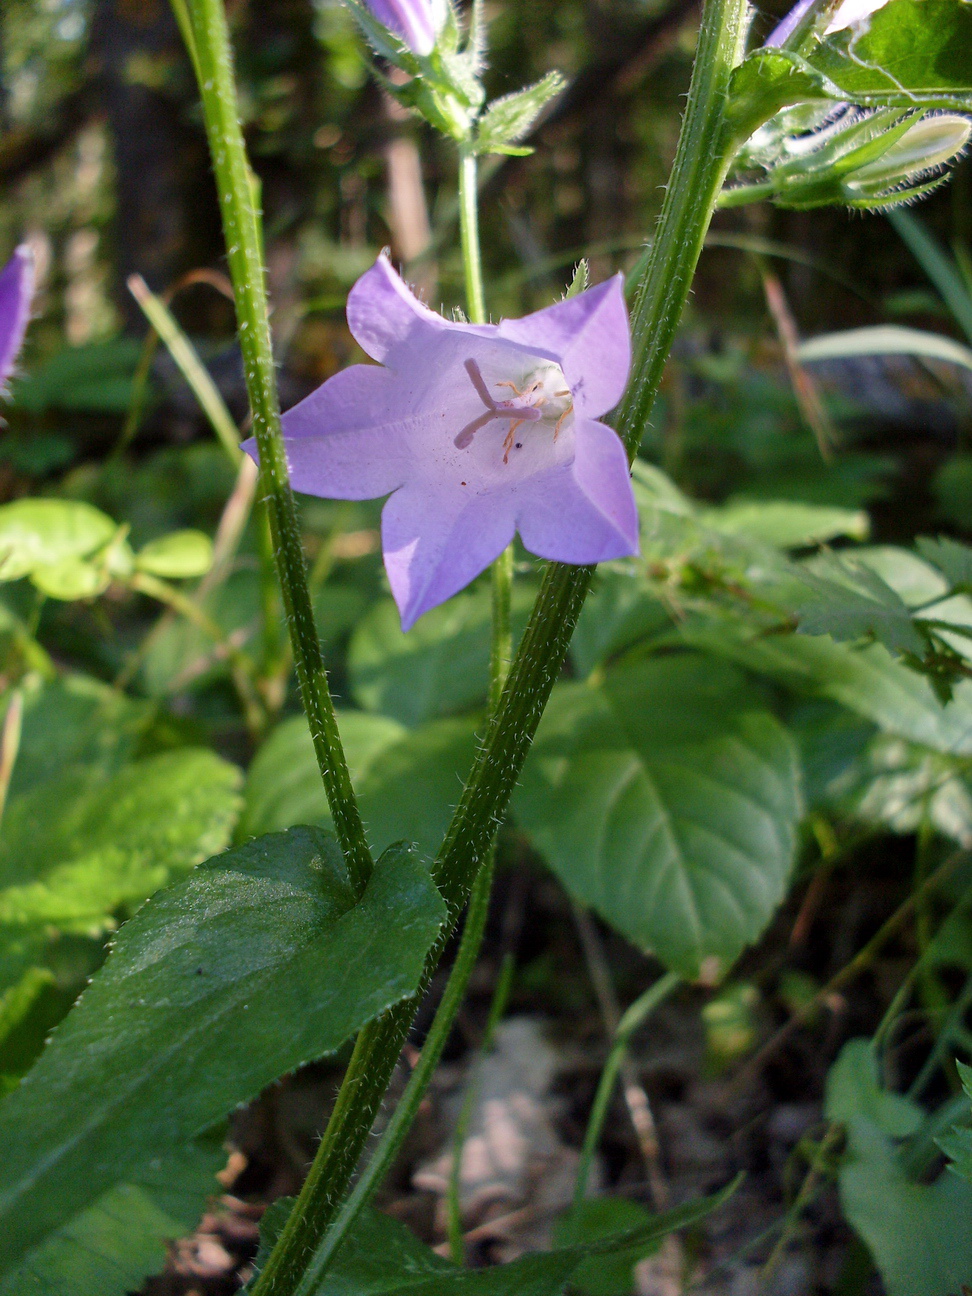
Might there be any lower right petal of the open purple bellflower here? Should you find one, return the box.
[517,419,638,564]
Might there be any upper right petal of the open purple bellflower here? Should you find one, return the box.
[499,275,631,419]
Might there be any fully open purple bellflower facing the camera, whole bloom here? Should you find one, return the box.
[255,255,638,630]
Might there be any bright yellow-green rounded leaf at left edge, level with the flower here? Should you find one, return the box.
[0,499,118,581]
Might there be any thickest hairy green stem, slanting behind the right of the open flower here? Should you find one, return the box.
[251,0,745,1280]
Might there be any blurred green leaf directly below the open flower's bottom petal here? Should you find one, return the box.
[347,588,533,724]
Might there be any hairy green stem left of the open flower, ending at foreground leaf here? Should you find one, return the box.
[176,0,373,892]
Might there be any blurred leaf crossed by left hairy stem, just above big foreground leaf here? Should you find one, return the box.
[241,712,476,855]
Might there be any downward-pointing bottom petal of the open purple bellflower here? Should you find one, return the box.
[381,482,513,630]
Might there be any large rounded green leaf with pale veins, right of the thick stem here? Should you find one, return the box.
[513,653,801,976]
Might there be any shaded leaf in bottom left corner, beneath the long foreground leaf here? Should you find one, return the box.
[0,1139,226,1296]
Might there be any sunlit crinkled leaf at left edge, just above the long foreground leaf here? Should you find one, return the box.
[0,748,241,936]
